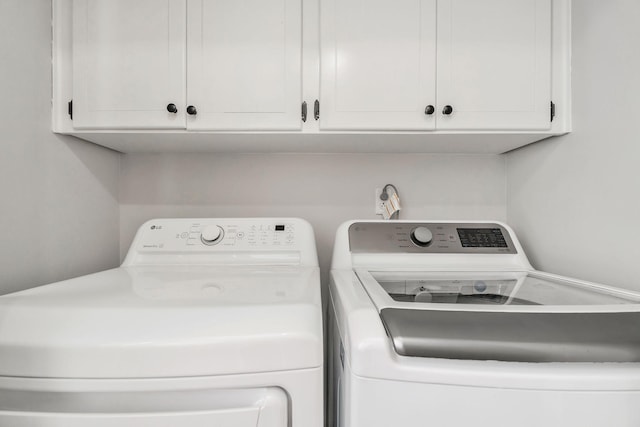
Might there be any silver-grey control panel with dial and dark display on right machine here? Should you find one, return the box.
[349,221,517,254]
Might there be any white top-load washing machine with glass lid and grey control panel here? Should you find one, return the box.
[328,221,640,427]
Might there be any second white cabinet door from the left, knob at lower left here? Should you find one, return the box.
[187,0,302,130]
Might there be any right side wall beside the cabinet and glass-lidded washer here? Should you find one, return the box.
[507,0,640,290]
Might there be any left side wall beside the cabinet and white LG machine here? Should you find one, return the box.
[0,0,119,294]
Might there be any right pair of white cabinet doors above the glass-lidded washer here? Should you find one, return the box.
[320,0,551,131]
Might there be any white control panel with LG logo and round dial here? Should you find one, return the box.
[136,219,298,252]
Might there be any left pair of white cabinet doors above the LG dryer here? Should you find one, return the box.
[73,0,302,130]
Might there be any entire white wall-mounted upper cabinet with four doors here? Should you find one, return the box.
[52,0,571,153]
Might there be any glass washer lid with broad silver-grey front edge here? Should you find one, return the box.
[356,270,640,362]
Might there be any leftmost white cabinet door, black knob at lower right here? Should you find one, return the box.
[73,0,186,129]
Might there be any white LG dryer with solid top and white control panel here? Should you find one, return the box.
[0,218,323,427]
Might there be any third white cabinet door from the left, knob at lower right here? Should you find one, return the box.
[320,0,436,130]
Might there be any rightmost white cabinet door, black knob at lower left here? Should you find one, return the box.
[437,0,551,130]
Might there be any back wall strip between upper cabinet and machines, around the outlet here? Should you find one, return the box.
[120,154,506,280]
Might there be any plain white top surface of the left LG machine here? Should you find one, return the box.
[0,266,322,378]
